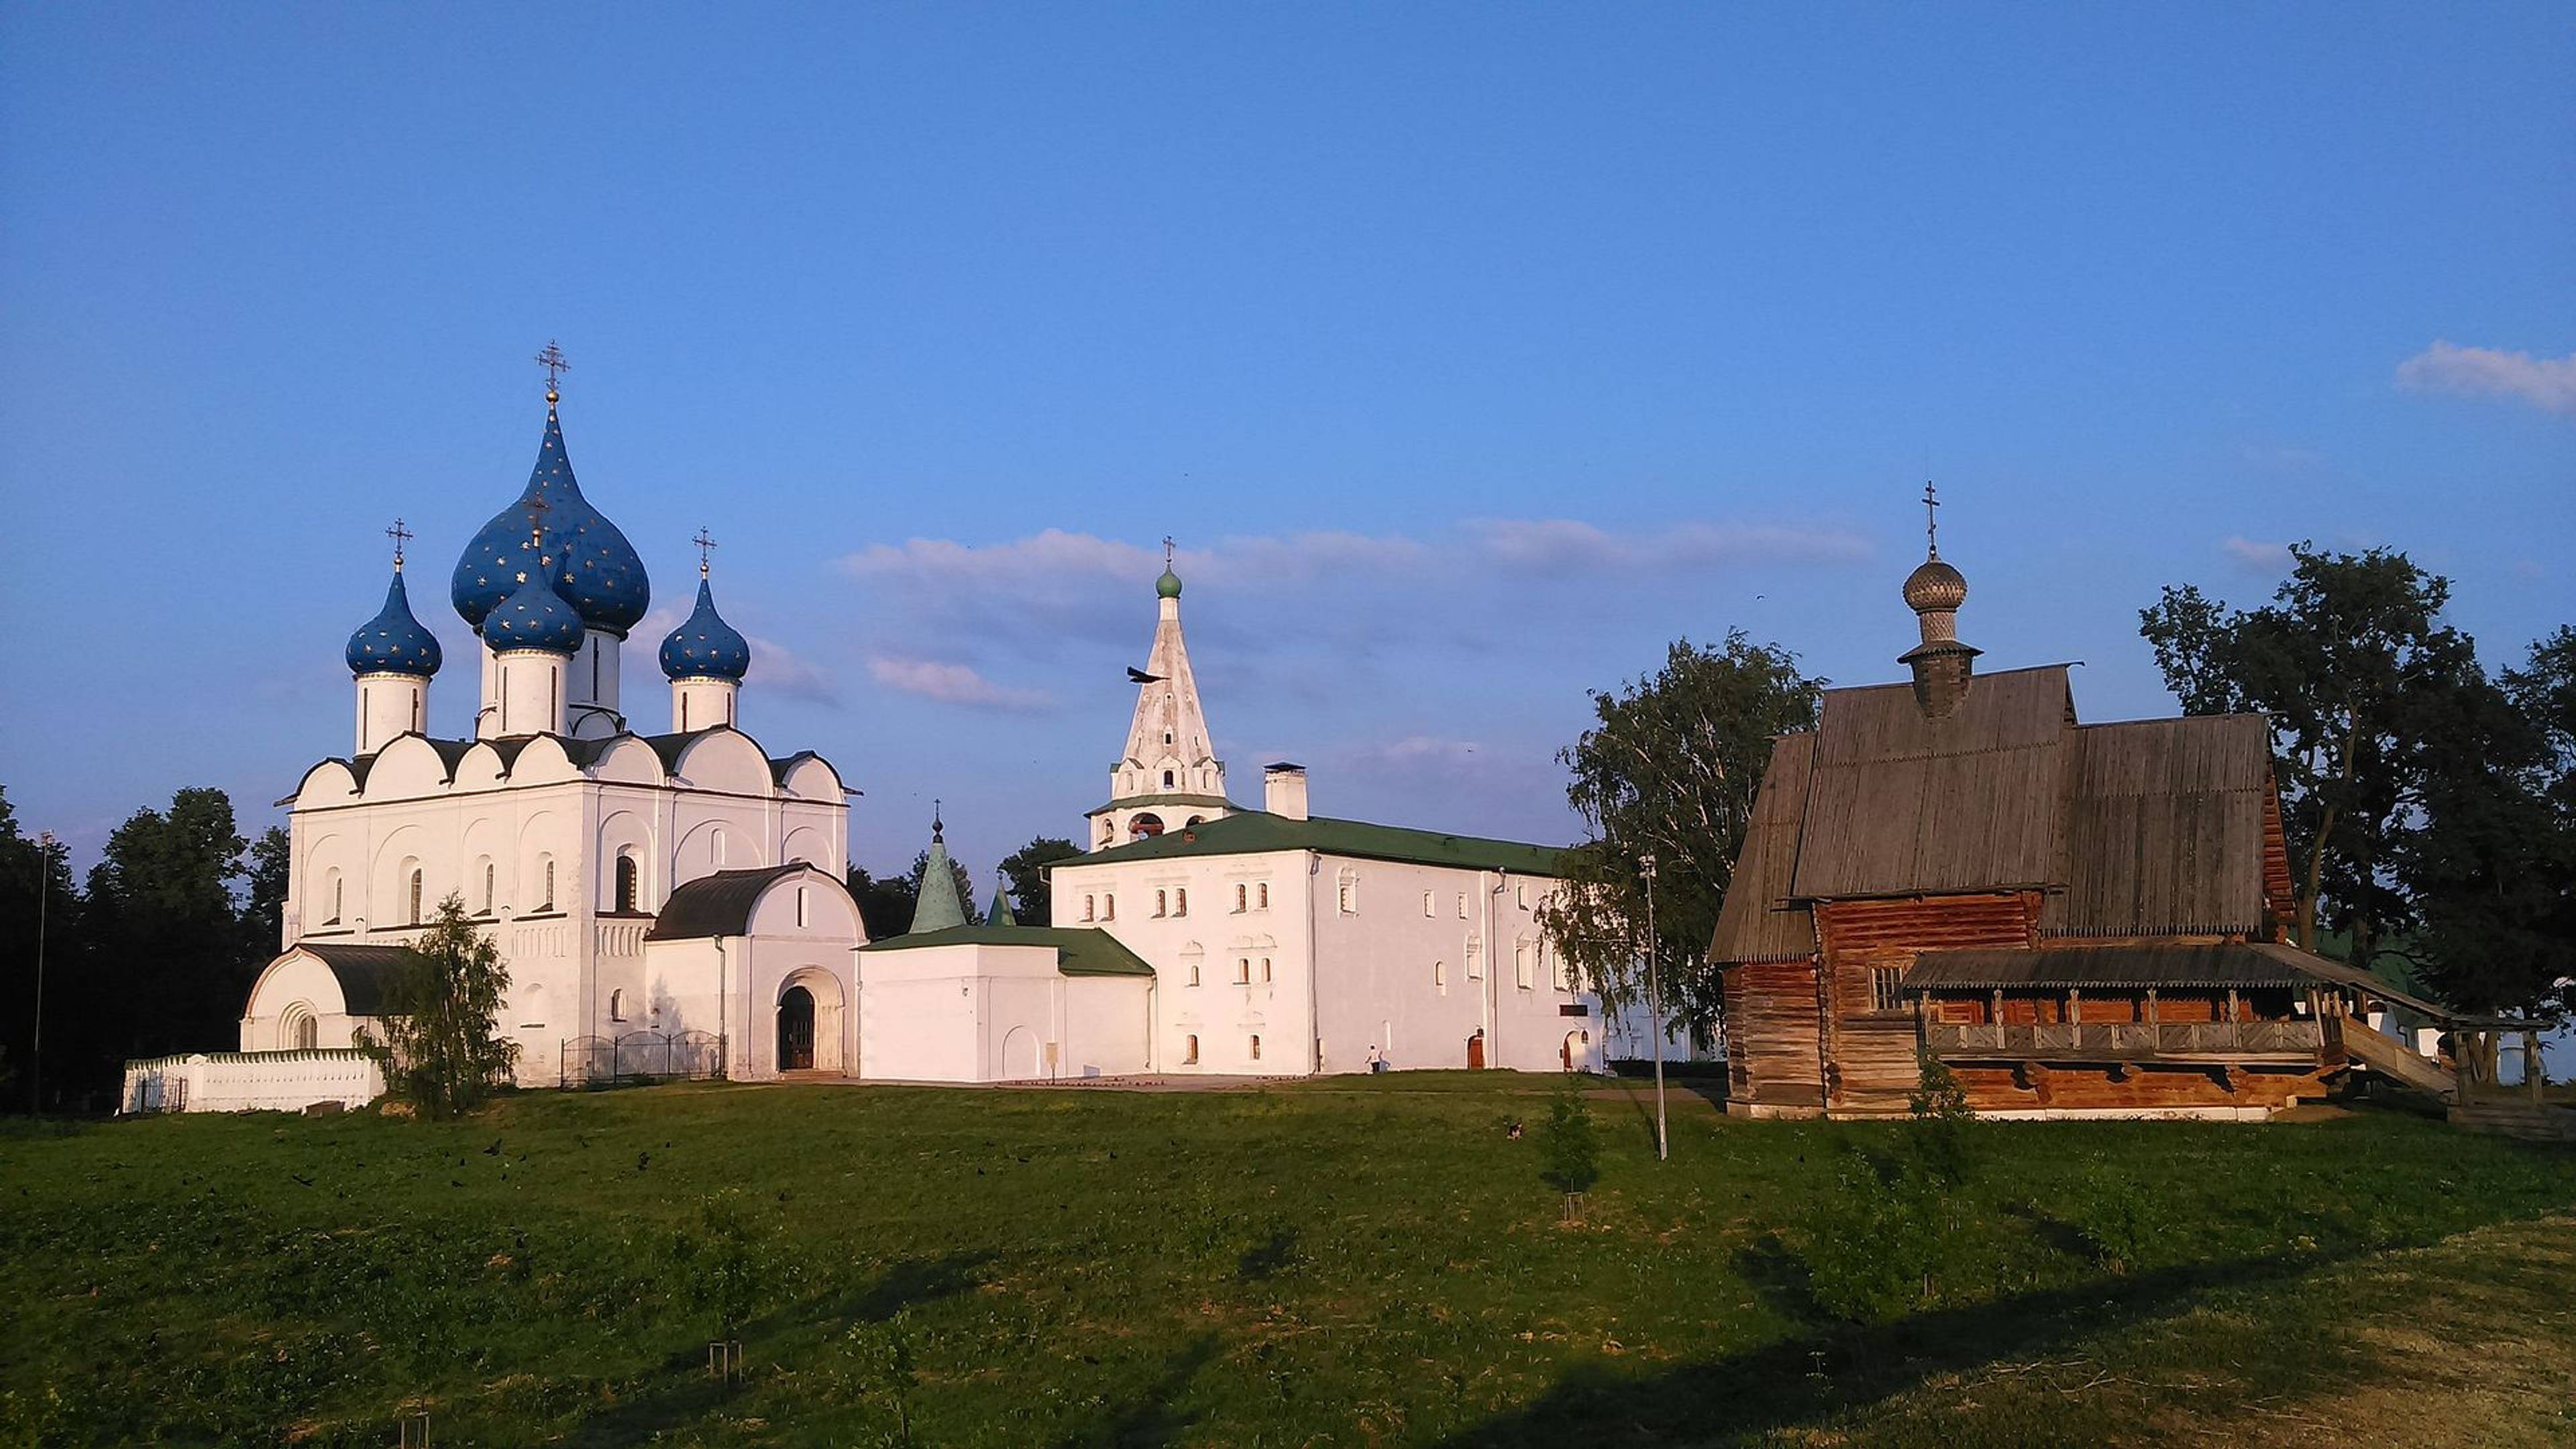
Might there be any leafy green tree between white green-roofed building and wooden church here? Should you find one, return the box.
[1540,632,1824,1046]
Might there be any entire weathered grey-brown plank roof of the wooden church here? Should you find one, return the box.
[1711,665,2288,962]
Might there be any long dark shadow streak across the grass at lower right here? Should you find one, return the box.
[1442,1238,2367,1449]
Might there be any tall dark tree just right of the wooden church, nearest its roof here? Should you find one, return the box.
[2141,544,2486,967]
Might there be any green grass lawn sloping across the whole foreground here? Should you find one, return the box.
[0,1073,2576,1449]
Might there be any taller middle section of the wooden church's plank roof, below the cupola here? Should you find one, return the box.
[1790,665,2074,900]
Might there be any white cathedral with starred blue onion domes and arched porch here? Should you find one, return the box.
[239,387,865,1085]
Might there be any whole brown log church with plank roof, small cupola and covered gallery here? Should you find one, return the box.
[1711,518,2414,1116]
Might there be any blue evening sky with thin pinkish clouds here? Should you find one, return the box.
[0,5,2576,869]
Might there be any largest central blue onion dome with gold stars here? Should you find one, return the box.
[448,397,652,639]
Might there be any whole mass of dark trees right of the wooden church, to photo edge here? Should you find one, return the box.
[2141,544,2576,1008]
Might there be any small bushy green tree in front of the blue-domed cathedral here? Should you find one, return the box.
[358,895,518,1116]
